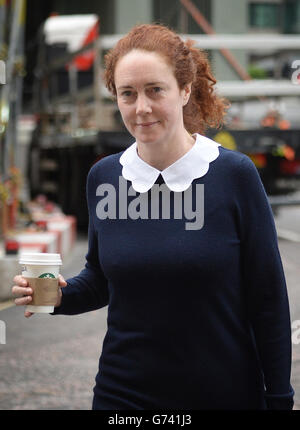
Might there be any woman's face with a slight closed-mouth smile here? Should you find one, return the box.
[115,50,190,147]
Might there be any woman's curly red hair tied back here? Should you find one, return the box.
[104,24,229,134]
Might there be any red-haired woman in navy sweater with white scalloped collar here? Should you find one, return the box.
[13,25,294,410]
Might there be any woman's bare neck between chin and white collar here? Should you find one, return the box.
[137,130,195,171]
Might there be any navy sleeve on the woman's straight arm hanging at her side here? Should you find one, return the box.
[237,156,294,409]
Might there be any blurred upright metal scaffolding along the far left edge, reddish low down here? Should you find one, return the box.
[0,0,26,239]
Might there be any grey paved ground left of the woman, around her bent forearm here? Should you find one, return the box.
[0,237,107,410]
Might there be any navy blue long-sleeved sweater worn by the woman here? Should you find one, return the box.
[54,147,294,410]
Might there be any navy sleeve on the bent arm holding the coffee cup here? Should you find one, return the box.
[53,166,109,315]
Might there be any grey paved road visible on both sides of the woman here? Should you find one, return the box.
[0,202,300,410]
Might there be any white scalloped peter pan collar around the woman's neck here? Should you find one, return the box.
[120,133,220,193]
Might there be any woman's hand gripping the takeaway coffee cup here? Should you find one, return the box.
[11,275,67,318]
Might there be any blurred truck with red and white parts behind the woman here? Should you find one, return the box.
[28,14,300,231]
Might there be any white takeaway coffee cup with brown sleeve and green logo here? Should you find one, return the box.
[19,252,62,313]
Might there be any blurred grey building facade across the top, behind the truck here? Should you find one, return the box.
[44,0,300,80]
